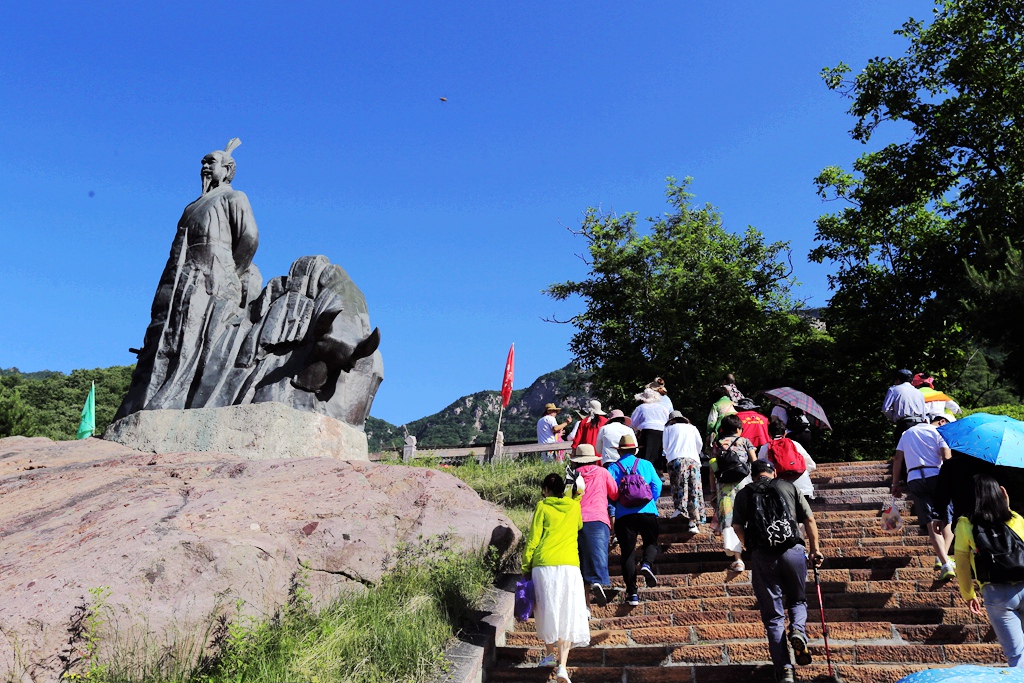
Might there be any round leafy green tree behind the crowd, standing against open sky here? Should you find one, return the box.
[546,178,811,423]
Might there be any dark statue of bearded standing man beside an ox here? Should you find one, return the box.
[117,138,383,427]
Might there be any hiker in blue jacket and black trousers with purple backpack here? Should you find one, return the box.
[608,434,662,605]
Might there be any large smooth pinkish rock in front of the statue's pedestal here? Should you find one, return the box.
[0,437,519,681]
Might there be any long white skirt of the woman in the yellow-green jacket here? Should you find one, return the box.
[532,564,590,647]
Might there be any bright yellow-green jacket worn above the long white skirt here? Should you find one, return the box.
[522,496,583,573]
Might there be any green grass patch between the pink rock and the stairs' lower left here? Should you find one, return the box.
[75,536,495,683]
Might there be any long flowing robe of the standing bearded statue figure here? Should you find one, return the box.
[117,184,262,418]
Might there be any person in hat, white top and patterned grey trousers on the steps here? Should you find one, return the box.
[663,411,705,533]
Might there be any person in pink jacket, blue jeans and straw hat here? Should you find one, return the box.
[570,443,618,607]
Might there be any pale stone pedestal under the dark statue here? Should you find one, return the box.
[103,402,370,461]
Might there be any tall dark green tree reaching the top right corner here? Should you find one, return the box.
[810,0,1024,454]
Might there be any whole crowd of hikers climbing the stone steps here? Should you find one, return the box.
[522,371,1024,683]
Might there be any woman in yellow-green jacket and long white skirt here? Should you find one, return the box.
[522,473,590,683]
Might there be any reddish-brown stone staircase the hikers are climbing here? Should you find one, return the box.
[484,462,1005,683]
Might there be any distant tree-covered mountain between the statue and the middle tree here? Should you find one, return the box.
[367,364,591,453]
